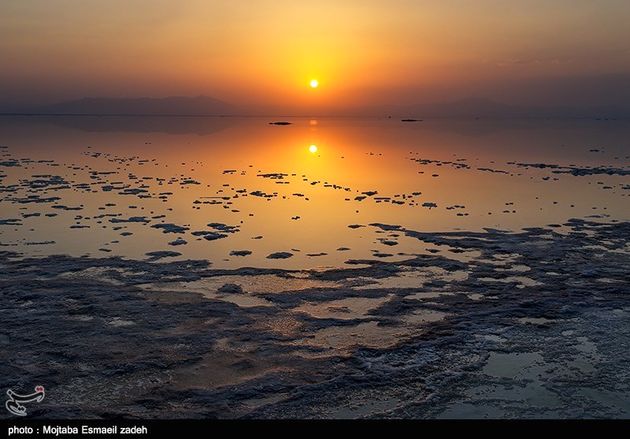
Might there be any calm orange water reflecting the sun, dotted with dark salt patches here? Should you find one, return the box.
[0,117,630,269]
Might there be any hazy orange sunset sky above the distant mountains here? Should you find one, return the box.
[0,0,630,110]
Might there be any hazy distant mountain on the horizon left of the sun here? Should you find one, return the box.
[28,96,236,116]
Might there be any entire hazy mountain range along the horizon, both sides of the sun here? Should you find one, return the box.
[6,96,630,119]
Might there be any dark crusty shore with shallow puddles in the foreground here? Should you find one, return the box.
[0,219,630,418]
